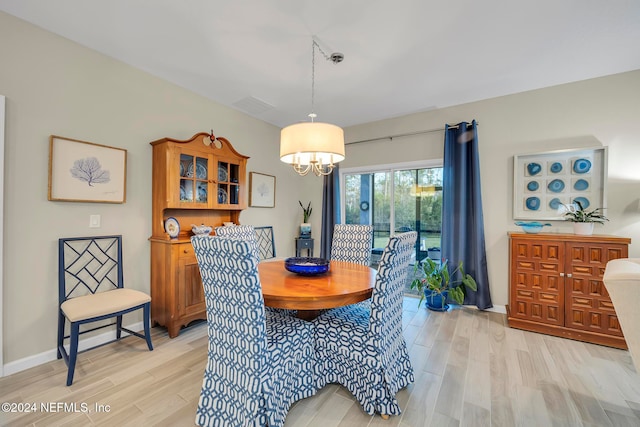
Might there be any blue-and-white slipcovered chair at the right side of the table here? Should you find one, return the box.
[312,231,417,418]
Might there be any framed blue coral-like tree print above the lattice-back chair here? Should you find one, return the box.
[48,135,127,203]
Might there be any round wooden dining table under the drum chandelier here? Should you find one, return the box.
[258,261,377,320]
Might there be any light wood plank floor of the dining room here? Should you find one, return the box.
[0,297,640,427]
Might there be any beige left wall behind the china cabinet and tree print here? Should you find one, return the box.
[0,12,304,363]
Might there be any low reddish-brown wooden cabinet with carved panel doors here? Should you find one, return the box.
[507,233,631,349]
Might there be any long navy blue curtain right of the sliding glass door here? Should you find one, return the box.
[442,120,493,310]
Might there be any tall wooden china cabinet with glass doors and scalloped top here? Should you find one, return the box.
[149,133,248,338]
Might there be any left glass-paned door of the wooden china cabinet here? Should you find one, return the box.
[180,153,209,206]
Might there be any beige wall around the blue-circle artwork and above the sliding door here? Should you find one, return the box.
[341,71,640,305]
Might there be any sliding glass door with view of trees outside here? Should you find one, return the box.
[342,167,442,260]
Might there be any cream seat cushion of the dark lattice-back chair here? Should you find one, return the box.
[60,288,151,322]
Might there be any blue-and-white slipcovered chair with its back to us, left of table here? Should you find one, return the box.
[191,236,317,426]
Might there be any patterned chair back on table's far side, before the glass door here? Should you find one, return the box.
[331,224,373,266]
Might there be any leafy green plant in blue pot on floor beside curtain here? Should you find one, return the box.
[411,258,478,311]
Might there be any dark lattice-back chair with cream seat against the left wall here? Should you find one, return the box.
[57,235,153,385]
